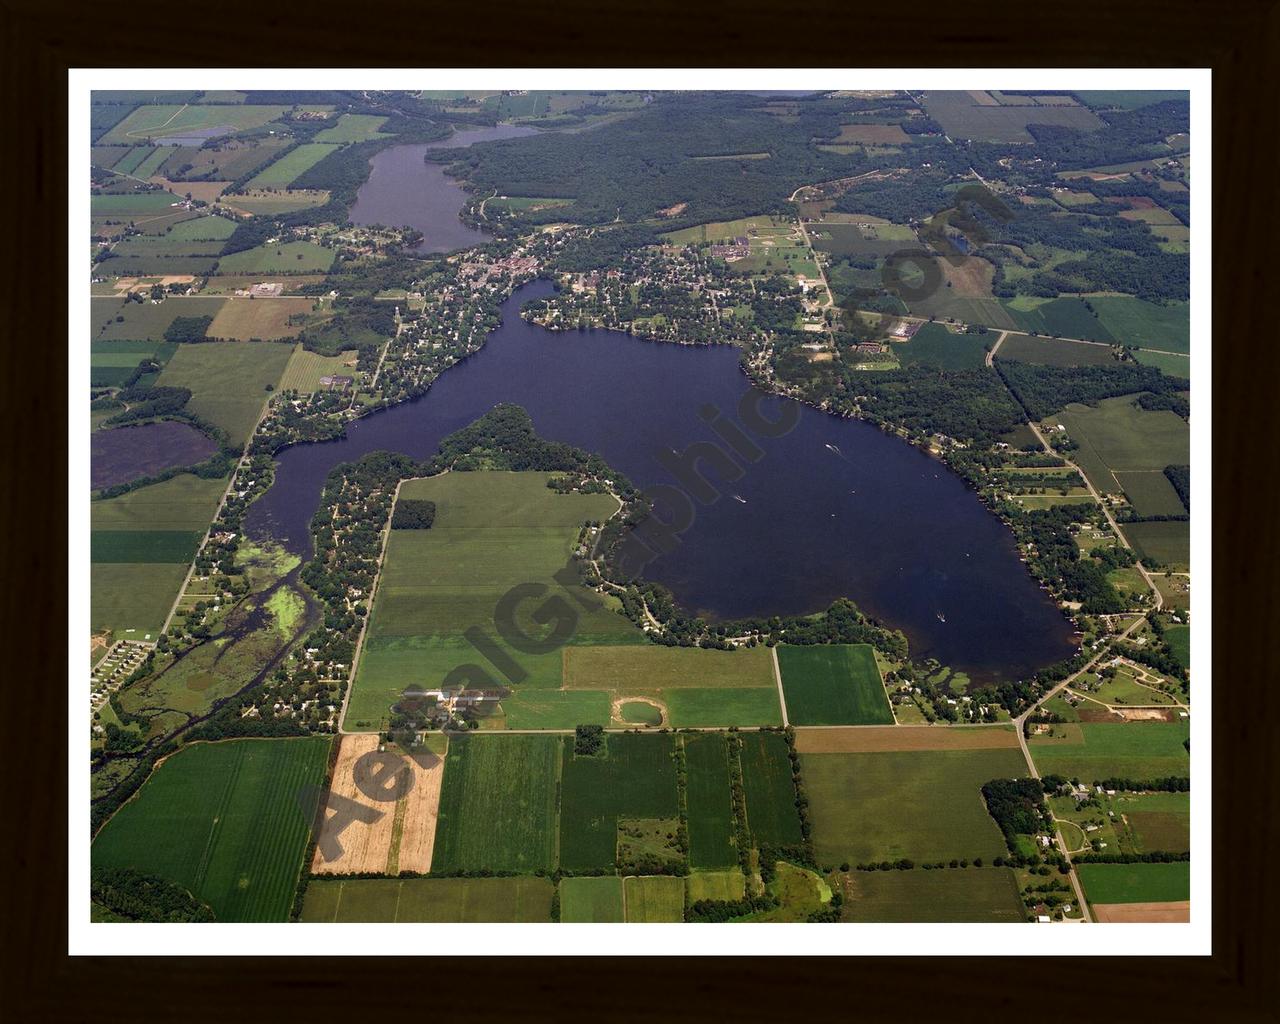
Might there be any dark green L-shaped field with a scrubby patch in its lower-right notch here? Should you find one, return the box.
[560,732,680,870]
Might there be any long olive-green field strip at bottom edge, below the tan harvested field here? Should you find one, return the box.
[301,877,556,924]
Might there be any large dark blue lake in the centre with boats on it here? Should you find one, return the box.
[246,282,1075,681]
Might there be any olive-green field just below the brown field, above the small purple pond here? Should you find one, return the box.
[157,342,293,445]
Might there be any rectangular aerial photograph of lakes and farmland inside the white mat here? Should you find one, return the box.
[85,83,1192,943]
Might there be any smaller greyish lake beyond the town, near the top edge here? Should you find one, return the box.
[351,124,538,252]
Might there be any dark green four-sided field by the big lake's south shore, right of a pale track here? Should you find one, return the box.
[777,644,893,726]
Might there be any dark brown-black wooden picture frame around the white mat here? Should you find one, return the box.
[0,0,1280,1024]
